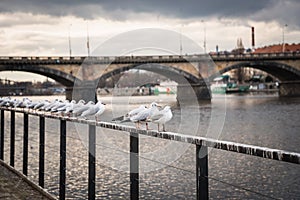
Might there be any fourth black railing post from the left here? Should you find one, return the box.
[39,116,45,187]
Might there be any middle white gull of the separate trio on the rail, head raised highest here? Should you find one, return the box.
[130,102,159,130]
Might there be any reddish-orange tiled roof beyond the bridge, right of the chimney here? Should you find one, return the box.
[254,43,300,53]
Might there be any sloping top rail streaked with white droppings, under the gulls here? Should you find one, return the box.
[0,107,300,164]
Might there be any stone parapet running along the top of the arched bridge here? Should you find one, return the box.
[0,52,300,64]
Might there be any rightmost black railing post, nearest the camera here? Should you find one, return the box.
[196,145,208,200]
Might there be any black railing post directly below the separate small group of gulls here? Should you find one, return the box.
[130,133,139,200]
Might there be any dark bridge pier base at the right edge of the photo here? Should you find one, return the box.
[279,81,300,97]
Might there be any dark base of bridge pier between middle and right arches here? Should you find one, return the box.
[177,84,211,103]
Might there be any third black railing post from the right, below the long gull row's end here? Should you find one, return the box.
[88,125,96,200]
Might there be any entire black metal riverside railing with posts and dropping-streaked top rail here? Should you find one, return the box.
[0,107,300,199]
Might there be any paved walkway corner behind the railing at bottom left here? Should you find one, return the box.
[0,160,56,200]
